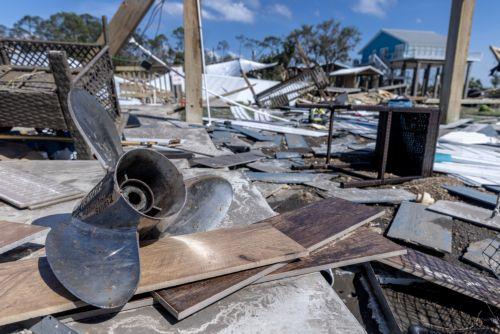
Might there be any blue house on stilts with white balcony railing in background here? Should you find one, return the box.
[359,29,482,97]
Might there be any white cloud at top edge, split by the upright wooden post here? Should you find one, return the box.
[164,0,260,23]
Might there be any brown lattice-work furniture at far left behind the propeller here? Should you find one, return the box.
[0,39,120,159]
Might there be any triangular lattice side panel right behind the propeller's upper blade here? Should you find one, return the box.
[75,49,119,120]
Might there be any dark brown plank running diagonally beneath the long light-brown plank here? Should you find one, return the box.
[153,198,384,320]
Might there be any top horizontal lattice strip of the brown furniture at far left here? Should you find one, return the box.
[0,39,102,68]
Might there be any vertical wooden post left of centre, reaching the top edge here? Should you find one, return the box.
[184,0,203,124]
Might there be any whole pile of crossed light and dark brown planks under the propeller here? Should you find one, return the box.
[0,198,406,325]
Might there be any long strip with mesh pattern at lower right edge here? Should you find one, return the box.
[379,249,500,307]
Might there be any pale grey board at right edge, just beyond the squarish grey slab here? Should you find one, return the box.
[427,200,500,231]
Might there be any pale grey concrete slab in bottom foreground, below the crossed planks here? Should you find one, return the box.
[66,273,365,334]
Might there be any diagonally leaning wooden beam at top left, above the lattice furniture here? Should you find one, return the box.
[97,0,155,56]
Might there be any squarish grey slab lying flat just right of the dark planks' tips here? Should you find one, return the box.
[387,202,453,253]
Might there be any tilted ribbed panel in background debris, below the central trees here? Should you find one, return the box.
[256,66,328,108]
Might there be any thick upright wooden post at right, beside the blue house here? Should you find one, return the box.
[439,0,476,123]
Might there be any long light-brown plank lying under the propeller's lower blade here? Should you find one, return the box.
[0,223,307,325]
